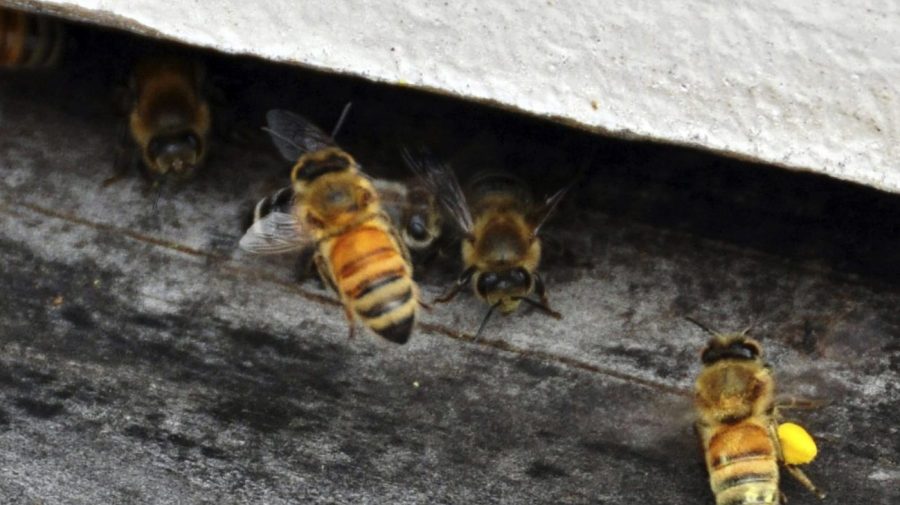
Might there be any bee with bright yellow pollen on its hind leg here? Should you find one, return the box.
[691,320,824,505]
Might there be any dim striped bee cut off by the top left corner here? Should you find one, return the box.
[0,7,65,69]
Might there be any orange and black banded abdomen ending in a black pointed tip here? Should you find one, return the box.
[323,218,419,344]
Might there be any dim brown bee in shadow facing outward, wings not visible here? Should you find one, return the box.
[105,57,211,184]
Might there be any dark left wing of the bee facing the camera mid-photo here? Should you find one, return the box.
[403,149,475,235]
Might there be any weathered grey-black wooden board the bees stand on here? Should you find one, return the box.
[0,26,900,504]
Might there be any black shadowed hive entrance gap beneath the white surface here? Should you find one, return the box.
[4,17,900,284]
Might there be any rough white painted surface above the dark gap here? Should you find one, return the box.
[7,0,900,192]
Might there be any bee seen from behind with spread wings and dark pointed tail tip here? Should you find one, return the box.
[240,110,420,344]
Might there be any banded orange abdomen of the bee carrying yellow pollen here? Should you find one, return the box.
[701,420,779,505]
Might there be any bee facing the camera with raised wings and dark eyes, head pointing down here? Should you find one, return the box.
[404,151,572,339]
